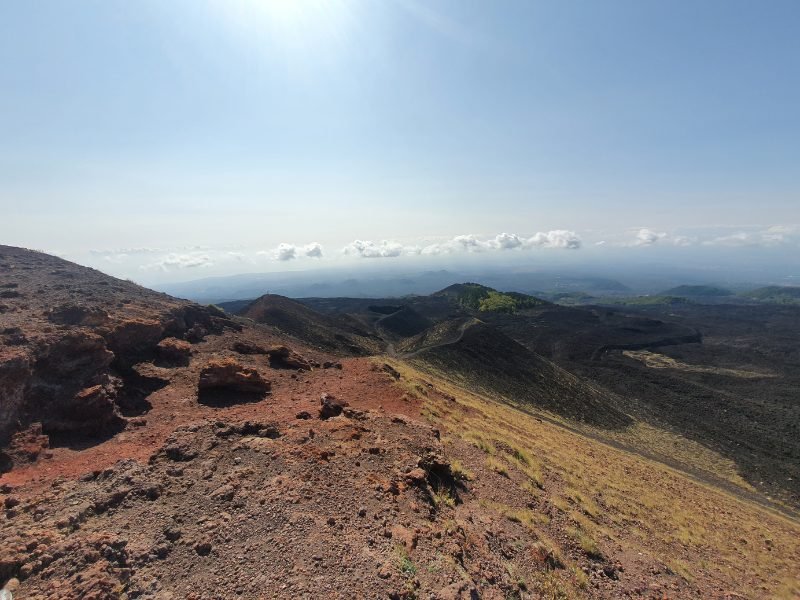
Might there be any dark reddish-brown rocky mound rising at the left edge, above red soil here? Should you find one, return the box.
[0,246,241,462]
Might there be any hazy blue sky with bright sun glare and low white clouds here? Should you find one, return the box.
[0,0,800,282]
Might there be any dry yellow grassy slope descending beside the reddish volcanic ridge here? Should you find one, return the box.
[382,361,800,599]
